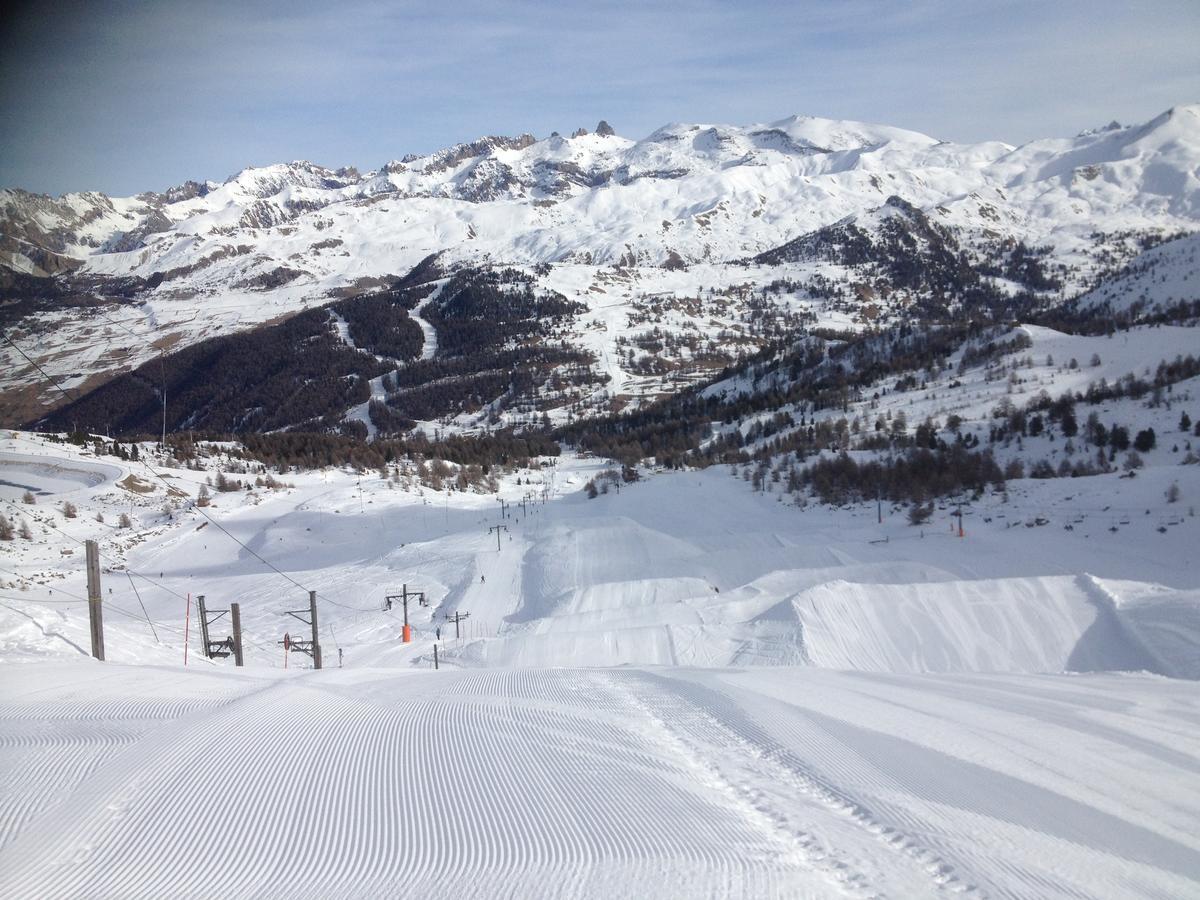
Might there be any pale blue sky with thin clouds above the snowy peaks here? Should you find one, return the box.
[0,0,1200,194]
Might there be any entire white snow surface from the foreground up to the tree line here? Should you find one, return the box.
[0,437,1200,898]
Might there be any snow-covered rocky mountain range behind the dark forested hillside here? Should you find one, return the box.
[0,104,1200,432]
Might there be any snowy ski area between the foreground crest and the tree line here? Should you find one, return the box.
[0,436,1200,679]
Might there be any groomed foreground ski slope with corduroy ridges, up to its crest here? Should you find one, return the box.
[0,664,1200,898]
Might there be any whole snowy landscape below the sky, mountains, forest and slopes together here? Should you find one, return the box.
[0,107,1200,900]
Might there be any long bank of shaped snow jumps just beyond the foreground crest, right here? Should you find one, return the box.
[460,572,1200,678]
